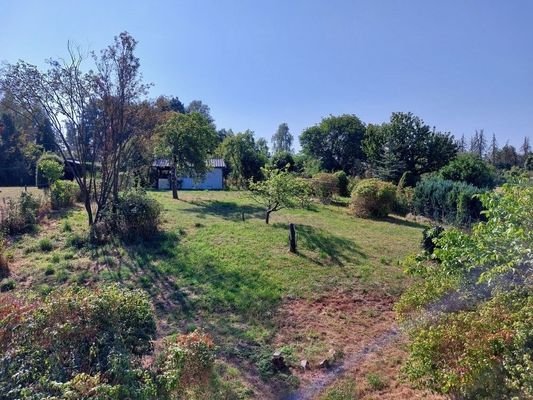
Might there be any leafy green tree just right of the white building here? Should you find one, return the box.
[218,130,268,188]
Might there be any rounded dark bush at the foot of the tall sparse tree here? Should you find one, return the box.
[104,190,161,241]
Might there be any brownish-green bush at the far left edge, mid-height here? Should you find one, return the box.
[0,192,40,235]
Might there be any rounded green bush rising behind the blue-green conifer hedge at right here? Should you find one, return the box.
[439,153,496,188]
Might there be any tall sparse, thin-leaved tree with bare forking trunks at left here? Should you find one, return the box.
[0,32,150,225]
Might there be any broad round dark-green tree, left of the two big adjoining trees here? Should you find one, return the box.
[300,114,365,175]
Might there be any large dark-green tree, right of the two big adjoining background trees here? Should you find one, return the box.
[363,113,457,185]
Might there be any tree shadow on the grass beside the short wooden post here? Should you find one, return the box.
[273,223,368,267]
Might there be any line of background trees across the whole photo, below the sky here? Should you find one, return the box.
[0,32,532,225]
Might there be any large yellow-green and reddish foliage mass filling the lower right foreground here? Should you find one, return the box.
[397,181,533,399]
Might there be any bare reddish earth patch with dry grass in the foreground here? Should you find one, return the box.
[275,290,443,400]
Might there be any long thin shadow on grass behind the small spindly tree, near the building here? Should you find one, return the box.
[181,200,265,221]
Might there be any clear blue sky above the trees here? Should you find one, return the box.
[0,0,533,150]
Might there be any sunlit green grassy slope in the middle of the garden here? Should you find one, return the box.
[3,192,420,396]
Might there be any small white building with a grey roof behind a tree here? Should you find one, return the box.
[152,158,226,190]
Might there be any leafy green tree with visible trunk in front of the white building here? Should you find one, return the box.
[157,112,217,199]
